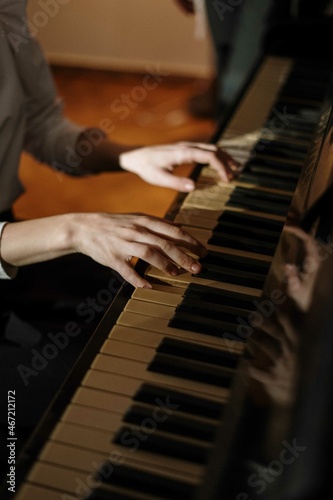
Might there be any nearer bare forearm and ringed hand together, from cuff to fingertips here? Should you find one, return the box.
[1,213,206,287]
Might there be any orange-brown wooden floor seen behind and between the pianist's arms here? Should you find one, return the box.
[14,67,216,219]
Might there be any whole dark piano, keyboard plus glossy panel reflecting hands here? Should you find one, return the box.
[1,42,333,500]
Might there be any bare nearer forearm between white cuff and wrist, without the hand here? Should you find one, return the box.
[1,214,75,267]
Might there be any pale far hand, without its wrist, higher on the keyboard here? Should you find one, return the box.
[119,142,239,193]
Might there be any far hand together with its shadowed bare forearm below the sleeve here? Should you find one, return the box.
[67,133,239,192]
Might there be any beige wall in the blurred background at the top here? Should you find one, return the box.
[28,0,212,77]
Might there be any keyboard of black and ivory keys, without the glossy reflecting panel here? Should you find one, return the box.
[16,57,328,500]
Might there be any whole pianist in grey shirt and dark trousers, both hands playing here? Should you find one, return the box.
[0,0,237,478]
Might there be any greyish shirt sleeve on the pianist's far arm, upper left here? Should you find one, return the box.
[0,0,85,173]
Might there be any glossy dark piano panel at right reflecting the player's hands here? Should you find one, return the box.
[196,92,333,500]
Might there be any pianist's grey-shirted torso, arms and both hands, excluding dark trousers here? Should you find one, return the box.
[0,0,236,286]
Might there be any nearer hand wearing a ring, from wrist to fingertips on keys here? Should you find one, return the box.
[73,213,207,288]
